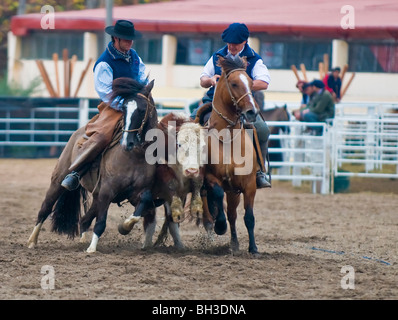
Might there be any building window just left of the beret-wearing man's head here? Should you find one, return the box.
[176,37,225,66]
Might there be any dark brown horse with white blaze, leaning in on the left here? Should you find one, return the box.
[28,78,158,252]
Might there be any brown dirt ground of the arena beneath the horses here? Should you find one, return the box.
[0,159,398,300]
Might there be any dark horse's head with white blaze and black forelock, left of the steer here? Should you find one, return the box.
[111,78,157,151]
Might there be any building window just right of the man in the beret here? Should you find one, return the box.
[259,41,332,71]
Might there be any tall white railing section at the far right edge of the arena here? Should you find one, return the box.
[331,114,398,185]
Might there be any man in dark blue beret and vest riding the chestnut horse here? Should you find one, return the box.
[191,23,271,188]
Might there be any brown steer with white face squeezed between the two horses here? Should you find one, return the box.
[119,113,205,248]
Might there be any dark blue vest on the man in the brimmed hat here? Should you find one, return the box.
[93,42,140,81]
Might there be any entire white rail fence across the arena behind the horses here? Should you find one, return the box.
[0,98,398,194]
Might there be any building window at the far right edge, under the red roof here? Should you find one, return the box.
[348,43,398,72]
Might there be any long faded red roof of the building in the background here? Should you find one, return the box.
[11,0,398,40]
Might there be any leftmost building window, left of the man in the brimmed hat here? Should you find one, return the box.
[21,32,84,60]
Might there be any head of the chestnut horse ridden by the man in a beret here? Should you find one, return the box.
[216,56,258,122]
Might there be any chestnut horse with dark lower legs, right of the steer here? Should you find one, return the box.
[195,57,258,254]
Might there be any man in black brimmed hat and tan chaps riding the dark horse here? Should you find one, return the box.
[61,20,147,190]
